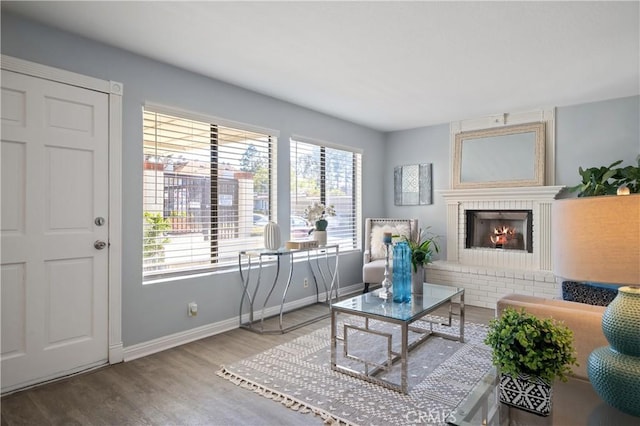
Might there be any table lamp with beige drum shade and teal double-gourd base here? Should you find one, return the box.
[551,191,640,416]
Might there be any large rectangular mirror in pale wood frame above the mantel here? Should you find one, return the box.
[453,123,545,189]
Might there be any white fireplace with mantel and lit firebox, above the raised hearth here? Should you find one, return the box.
[439,186,562,276]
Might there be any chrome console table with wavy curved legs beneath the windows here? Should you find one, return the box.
[238,245,340,334]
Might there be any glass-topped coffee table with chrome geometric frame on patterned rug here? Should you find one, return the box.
[331,283,464,394]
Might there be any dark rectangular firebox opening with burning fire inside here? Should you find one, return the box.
[465,210,533,253]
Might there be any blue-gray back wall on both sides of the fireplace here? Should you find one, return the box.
[384,96,640,259]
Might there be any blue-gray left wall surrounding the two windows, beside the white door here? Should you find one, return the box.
[2,13,384,346]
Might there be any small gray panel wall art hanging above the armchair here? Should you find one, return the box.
[393,163,432,206]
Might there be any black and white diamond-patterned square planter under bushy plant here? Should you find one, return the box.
[500,373,553,416]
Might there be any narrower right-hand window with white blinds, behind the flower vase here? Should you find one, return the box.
[291,137,362,250]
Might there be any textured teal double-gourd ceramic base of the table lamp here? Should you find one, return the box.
[587,287,640,417]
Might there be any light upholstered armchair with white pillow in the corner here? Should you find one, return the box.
[362,218,418,293]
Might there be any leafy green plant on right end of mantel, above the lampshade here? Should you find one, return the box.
[569,155,640,197]
